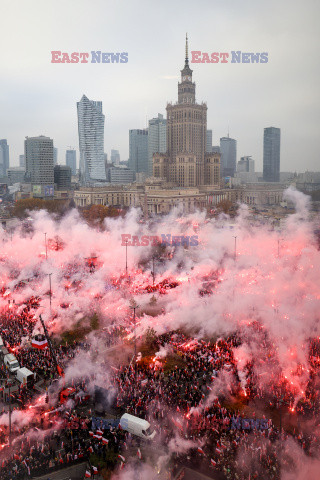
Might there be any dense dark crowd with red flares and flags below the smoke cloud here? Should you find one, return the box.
[0,299,320,480]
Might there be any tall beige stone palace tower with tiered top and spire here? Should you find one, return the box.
[153,34,220,187]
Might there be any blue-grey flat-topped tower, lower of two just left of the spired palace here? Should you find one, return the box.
[129,128,148,173]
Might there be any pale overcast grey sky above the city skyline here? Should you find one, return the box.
[0,0,320,171]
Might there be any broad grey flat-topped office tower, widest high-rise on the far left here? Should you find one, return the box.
[24,135,54,197]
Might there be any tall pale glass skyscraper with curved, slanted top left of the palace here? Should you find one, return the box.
[77,95,106,185]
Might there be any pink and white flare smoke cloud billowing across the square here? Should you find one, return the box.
[0,189,320,418]
